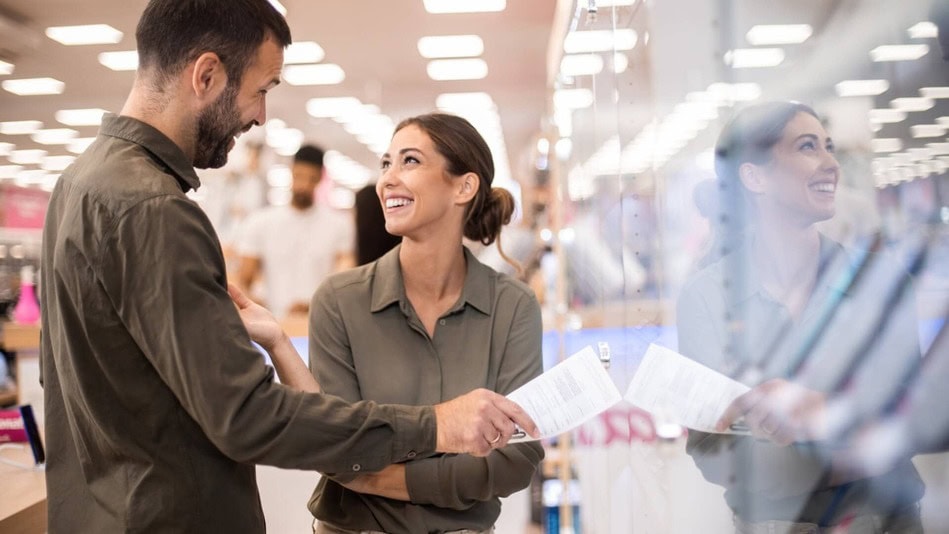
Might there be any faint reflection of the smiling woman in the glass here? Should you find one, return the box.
[677,102,923,533]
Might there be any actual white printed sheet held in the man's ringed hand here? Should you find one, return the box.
[507,347,622,441]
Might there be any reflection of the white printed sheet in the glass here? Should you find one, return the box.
[625,344,749,433]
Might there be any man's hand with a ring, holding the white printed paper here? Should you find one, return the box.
[435,389,538,456]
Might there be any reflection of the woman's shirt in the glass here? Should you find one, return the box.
[676,236,923,525]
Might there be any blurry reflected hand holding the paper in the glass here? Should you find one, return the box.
[715,378,826,446]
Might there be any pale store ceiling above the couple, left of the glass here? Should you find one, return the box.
[0,0,555,186]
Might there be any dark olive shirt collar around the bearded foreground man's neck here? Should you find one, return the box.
[99,113,201,191]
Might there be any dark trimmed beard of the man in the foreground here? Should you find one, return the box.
[194,83,246,169]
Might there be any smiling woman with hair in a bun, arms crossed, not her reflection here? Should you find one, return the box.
[310,113,543,534]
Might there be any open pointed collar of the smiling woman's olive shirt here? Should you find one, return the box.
[370,244,495,315]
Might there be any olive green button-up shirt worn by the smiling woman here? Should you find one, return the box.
[310,246,543,534]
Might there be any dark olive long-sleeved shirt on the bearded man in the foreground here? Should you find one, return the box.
[41,115,435,534]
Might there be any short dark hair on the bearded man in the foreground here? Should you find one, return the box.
[135,0,291,88]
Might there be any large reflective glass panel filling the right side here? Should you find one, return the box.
[548,0,949,533]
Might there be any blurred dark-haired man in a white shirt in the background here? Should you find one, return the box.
[235,145,355,317]
